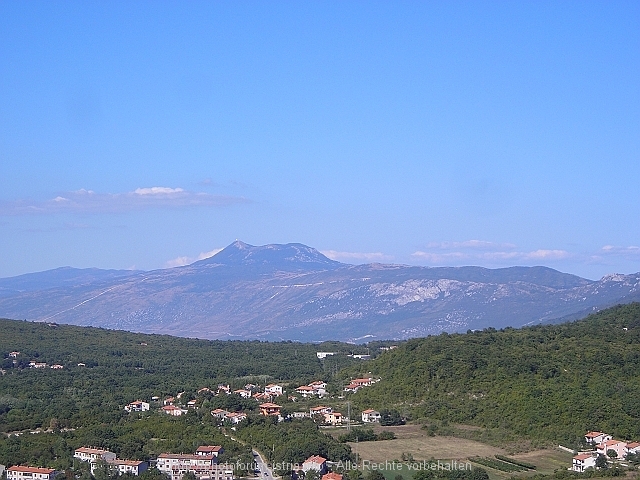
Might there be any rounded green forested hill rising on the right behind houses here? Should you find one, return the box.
[343,303,640,444]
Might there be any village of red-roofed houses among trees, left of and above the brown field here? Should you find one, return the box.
[0,376,381,480]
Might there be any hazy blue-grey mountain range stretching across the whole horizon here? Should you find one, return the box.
[0,241,640,341]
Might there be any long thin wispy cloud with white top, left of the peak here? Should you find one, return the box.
[0,187,248,216]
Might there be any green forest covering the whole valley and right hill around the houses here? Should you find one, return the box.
[0,303,640,469]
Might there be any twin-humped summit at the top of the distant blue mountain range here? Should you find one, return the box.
[196,240,342,271]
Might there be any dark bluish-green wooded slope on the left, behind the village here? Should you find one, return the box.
[0,319,367,432]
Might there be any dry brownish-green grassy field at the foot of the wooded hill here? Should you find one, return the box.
[342,425,571,480]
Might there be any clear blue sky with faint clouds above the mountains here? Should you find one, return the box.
[0,1,640,279]
